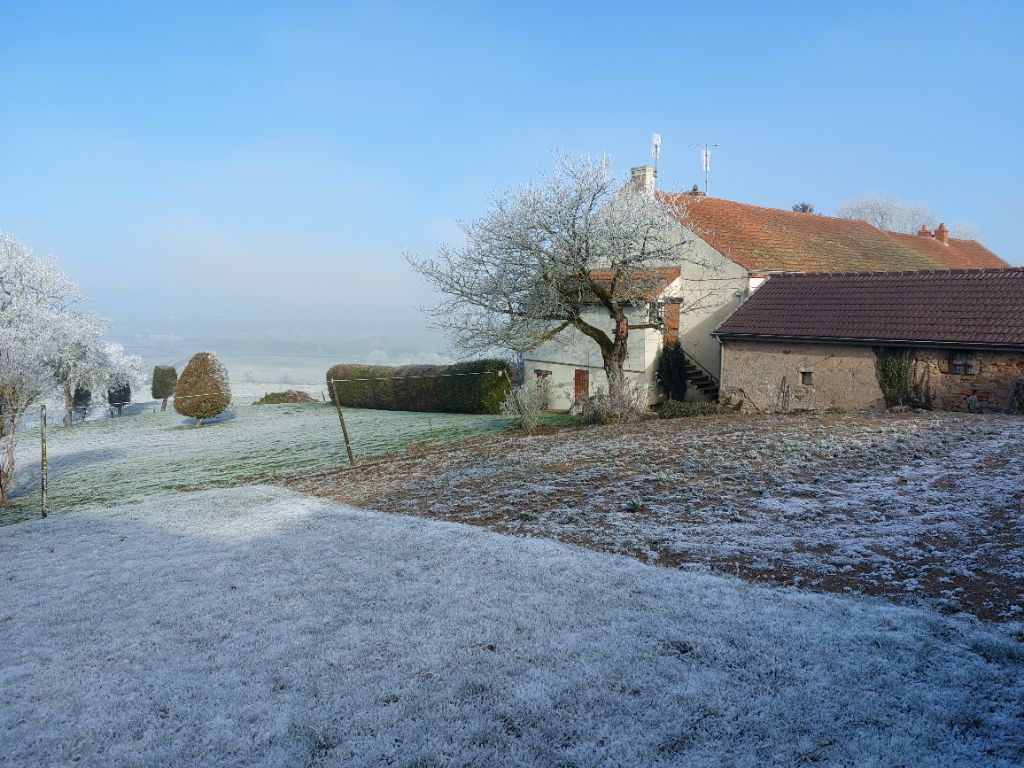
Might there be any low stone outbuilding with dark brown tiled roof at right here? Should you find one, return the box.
[715,268,1024,412]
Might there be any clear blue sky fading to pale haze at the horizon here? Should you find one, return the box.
[0,0,1024,353]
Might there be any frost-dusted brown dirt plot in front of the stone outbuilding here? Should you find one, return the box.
[286,414,1024,621]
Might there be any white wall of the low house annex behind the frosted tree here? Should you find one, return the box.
[522,307,662,411]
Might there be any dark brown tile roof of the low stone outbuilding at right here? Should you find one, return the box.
[717,268,1024,349]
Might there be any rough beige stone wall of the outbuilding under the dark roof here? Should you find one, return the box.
[721,340,1024,412]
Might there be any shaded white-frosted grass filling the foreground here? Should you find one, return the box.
[0,486,1024,768]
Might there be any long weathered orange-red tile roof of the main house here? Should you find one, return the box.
[665,194,1008,272]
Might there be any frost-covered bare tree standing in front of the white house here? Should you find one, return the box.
[407,157,681,398]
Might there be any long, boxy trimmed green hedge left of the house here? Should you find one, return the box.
[327,359,515,414]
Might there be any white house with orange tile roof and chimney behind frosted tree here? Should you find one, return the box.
[523,166,1007,410]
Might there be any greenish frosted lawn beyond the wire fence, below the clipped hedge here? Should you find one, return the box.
[0,403,512,523]
